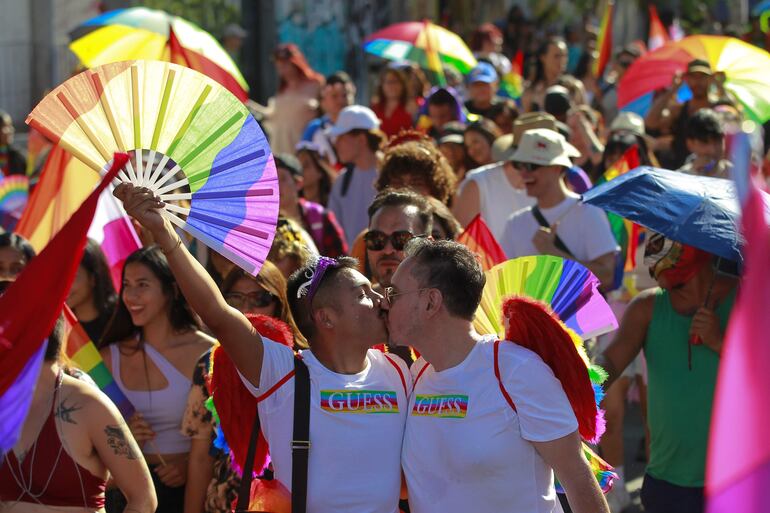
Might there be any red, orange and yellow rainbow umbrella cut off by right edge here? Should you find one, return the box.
[618,36,770,123]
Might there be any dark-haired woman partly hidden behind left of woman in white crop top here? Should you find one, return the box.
[67,239,117,341]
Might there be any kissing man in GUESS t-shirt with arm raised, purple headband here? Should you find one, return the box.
[115,184,411,513]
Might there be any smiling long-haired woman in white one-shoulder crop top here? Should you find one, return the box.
[100,246,214,513]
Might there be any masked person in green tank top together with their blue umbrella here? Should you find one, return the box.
[583,167,752,513]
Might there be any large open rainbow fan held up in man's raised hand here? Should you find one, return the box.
[27,61,278,275]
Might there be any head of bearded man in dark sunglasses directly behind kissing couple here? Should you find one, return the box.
[364,189,433,290]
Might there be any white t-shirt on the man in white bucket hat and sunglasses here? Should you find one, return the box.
[500,193,620,262]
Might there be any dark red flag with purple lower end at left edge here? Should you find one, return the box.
[0,153,128,454]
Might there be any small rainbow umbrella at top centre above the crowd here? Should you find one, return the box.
[364,20,476,74]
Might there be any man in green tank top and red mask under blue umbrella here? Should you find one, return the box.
[597,234,738,513]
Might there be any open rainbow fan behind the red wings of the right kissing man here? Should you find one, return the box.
[473,255,618,340]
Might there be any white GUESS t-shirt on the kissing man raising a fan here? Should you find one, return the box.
[241,338,411,513]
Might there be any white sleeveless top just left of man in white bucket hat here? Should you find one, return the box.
[459,162,535,241]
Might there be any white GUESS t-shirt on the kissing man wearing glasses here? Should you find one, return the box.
[402,336,577,513]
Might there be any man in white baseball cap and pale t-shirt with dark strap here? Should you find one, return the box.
[328,105,385,247]
